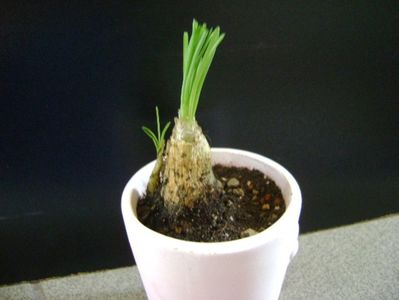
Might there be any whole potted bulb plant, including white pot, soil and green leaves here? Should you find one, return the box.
[122,20,301,300]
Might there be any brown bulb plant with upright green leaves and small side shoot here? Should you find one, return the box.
[145,20,225,213]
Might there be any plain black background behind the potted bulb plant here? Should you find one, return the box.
[0,1,399,284]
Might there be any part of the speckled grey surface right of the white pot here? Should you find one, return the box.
[280,214,399,300]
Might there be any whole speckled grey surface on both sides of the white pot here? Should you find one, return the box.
[0,214,399,300]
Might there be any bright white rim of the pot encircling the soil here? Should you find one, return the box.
[121,148,302,255]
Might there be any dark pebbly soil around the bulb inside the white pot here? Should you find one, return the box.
[137,165,285,242]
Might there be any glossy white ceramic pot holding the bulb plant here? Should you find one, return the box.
[122,148,302,300]
